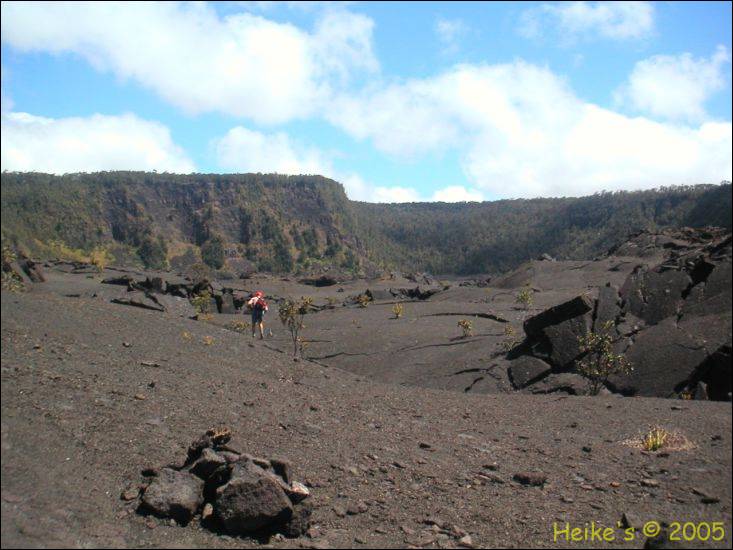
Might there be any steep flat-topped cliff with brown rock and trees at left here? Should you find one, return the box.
[2,172,365,271]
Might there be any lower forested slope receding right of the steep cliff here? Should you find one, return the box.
[354,183,731,275]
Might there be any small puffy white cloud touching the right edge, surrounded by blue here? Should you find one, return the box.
[616,46,730,121]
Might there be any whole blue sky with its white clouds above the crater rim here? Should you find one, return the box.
[2,2,732,202]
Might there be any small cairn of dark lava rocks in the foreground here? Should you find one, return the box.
[134,428,312,537]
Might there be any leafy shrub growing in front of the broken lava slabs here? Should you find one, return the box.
[578,321,634,395]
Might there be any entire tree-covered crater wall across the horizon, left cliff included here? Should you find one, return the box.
[1,172,731,276]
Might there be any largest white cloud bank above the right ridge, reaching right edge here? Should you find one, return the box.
[328,61,733,197]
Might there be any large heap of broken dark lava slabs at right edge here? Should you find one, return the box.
[508,229,732,401]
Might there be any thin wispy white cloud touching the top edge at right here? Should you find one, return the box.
[519,2,654,42]
